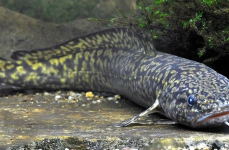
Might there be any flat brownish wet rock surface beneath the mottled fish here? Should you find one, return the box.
[0,91,229,149]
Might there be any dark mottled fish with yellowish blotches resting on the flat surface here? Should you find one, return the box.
[0,27,229,128]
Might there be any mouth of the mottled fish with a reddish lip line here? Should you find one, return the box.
[192,110,229,127]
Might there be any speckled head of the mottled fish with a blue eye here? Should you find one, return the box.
[160,70,229,128]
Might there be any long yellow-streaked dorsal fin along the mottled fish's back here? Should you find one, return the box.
[11,28,156,60]
